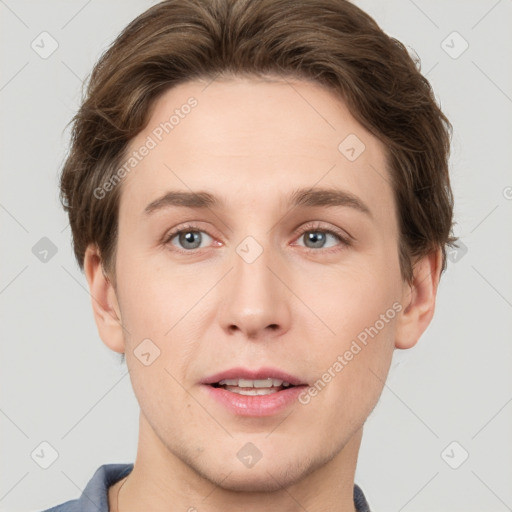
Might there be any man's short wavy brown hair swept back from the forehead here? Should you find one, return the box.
[61,0,456,282]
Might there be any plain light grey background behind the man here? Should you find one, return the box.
[0,0,512,512]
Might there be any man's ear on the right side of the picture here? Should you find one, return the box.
[395,249,443,349]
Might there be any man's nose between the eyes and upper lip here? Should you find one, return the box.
[218,240,292,341]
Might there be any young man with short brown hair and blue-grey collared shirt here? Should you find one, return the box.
[44,0,455,512]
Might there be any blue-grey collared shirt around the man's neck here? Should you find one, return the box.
[43,464,371,512]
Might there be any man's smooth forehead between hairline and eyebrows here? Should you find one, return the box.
[121,78,393,220]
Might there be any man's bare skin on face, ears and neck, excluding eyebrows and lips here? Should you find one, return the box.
[85,78,441,512]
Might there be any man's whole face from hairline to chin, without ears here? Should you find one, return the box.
[96,78,405,490]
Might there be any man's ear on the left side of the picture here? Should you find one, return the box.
[84,244,124,353]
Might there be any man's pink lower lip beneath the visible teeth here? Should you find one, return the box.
[203,384,307,416]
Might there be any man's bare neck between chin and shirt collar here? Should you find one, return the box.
[109,413,362,512]
